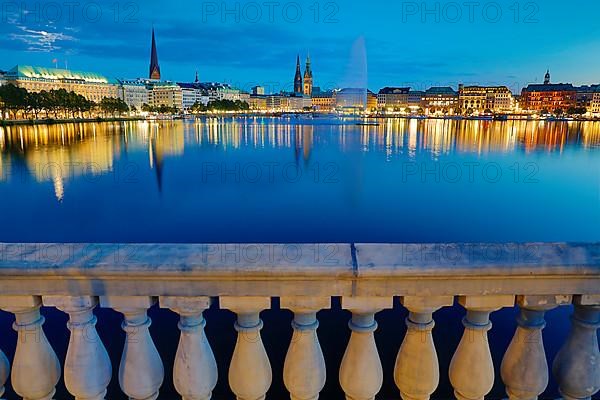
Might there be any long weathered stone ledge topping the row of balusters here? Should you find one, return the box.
[0,243,600,297]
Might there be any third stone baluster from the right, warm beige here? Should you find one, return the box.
[450,296,515,400]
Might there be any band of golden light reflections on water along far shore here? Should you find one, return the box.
[0,118,600,200]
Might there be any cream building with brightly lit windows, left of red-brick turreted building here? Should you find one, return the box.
[458,84,514,114]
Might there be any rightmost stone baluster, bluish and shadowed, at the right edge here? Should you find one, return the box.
[553,296,600,400]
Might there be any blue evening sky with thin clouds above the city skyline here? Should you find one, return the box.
[0,0,600,91]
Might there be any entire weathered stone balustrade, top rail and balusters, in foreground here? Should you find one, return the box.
[0,243,600,400]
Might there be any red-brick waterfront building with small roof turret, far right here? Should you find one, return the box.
[521,71,577,112]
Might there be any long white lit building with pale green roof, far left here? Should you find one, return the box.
[4,65,119,103]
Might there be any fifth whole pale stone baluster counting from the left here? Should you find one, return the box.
[220,297,272,400]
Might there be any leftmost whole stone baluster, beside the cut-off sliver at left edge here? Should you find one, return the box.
[0,296,60,400]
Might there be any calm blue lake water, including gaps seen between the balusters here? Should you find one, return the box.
[0,118,600,400]
